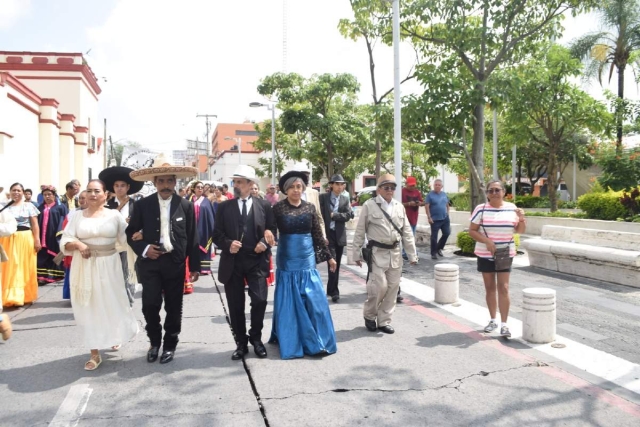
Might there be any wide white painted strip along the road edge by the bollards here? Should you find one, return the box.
[345,266,640,394]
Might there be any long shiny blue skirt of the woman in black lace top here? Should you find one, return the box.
[269,234,337,359]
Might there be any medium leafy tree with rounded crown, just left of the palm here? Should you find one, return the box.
[506,45,611,211]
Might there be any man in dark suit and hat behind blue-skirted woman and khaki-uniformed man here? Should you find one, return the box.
[320,175,353,302]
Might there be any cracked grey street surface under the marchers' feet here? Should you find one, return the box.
[0,251,640,427]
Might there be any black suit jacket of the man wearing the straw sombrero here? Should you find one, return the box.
[126,194,200,272]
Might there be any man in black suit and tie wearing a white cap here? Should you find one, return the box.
[213,165,276,360]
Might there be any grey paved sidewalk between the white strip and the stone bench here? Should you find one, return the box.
[404,246,640,363]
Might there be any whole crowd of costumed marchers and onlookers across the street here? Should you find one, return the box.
[0,155,526,370]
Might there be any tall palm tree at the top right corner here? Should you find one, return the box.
[571,0,640,151]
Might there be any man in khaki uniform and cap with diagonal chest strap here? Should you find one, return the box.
[353,174,418,334]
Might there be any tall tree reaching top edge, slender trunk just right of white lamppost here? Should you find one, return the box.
[401,0,592,204]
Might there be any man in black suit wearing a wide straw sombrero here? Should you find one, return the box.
[126,155,200,363]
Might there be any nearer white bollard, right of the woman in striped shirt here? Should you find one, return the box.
[522,288,556,344]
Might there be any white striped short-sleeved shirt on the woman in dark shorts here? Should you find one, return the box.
[471,202,520,258]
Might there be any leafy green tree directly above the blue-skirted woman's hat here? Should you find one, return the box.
[258,73,373,178]
